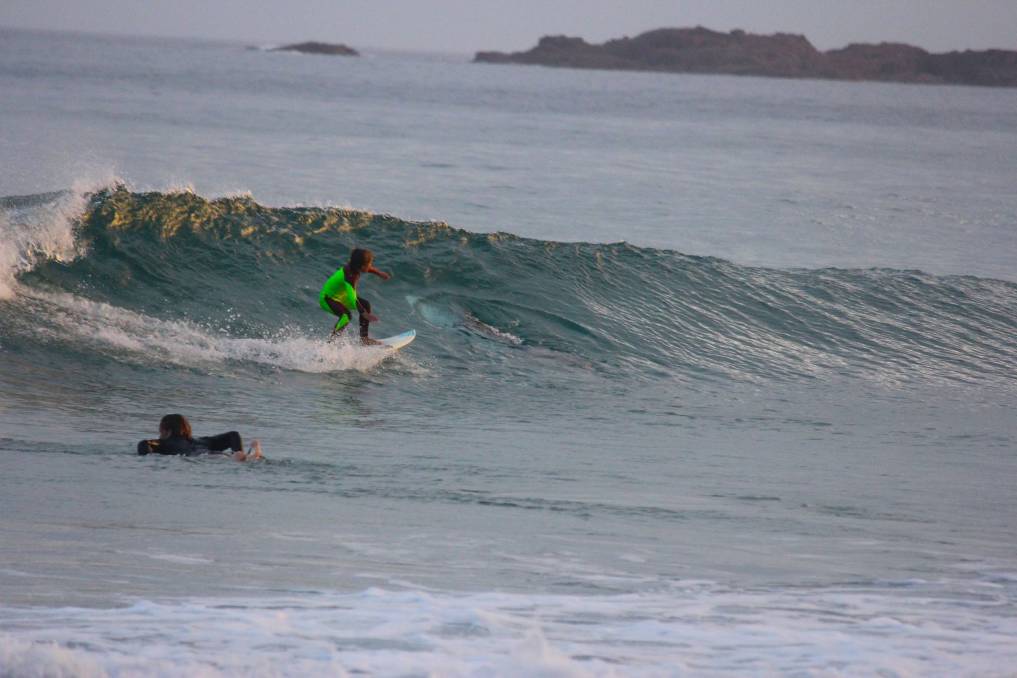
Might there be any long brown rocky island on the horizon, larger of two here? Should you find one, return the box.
[474,26,1017,87]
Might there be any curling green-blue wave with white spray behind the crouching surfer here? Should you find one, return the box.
[0,186,1017,388]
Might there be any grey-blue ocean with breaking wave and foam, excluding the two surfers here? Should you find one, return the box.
[0,25,1017,677]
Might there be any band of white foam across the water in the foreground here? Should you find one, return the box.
[0,585,1017,677]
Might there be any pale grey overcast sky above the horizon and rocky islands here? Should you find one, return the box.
[0,0,1017,53]
